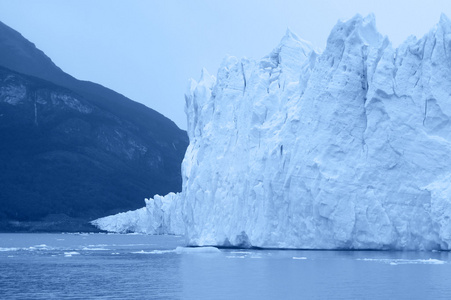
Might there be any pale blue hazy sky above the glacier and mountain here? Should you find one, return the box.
[0,0,451,129]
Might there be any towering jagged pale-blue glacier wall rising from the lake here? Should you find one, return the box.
[94,15,451,250]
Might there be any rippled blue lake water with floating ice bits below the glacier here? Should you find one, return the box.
[0,234,451,299]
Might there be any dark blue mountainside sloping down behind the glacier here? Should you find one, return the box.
[0,23,188,231]
